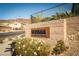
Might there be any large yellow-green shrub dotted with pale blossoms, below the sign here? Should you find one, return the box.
[15,38,51,56]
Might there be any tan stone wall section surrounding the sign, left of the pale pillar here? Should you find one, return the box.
[25,20,64,44]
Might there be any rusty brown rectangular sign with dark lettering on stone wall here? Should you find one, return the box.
[31,27,49,38]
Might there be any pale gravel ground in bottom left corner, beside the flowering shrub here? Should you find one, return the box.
[0,41,12,56]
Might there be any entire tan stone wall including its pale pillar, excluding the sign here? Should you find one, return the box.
[25,16,79,44]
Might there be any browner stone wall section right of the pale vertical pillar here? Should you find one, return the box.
[67,17,79,35]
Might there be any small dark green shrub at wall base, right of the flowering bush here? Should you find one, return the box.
[52,40,68,55]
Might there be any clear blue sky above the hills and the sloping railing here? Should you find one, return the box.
[0,3,72,20]
